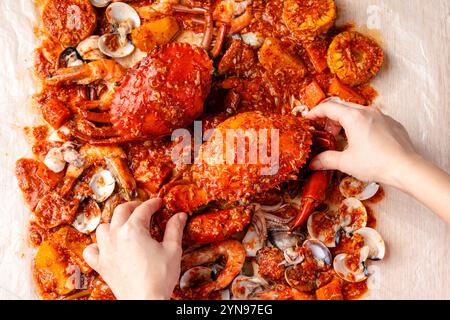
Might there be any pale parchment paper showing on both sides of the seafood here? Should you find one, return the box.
[0,0,450,299]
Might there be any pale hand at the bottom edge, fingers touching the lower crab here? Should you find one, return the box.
[83,199,187,300]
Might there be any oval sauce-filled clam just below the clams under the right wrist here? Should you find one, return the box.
[339,198,367,233]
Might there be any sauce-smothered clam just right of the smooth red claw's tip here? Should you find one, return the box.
[307,211,340,248]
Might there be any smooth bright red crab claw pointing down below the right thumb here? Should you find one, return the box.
[289,171,332,231]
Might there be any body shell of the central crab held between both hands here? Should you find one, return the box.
[192,112,312,201]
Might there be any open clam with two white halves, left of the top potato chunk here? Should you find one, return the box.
[98,2,141,58]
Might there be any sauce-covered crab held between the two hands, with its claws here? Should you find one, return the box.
[156,112,334,243]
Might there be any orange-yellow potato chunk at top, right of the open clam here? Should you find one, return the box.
[131,17,180,52]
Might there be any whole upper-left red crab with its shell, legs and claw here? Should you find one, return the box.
[47,43,212,144]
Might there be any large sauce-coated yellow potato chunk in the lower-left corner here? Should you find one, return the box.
[33,226,92,298]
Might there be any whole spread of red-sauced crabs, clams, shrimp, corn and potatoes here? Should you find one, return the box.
[15,0,385,300]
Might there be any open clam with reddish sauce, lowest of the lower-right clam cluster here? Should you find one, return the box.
[333,247,369,282]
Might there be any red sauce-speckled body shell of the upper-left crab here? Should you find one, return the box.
[111,43,212,139]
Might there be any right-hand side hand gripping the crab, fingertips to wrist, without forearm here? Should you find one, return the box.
[307,100,419,187]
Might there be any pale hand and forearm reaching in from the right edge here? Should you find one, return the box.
[307,101,450,226]
